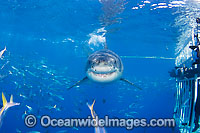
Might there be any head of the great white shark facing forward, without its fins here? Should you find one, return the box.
[86,49,123,83]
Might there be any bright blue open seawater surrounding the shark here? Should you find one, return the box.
[0,0,198,133]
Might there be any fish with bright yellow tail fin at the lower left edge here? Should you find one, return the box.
[0,92,20,127]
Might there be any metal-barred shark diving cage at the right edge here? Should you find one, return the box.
[169,18,200,133]
